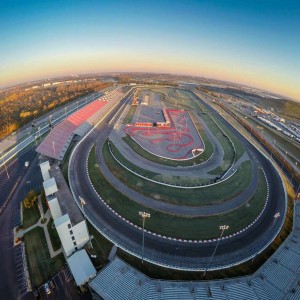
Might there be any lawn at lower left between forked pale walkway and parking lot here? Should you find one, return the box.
[24,227,65,288]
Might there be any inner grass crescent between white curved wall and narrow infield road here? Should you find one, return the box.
[103,139,251,206]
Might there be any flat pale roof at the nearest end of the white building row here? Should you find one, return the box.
[67,249,96,285]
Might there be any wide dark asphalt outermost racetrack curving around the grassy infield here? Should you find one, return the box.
[69,91,286,269]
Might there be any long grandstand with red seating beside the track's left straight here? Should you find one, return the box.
[36,87,124,161]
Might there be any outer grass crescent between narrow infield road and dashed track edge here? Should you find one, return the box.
[88,146,266,239]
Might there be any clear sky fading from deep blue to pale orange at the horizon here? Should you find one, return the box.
[0,0,300,99]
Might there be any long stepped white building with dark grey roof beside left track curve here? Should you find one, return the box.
[40,162,89,256]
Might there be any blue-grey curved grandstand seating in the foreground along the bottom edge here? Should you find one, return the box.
[89,201,300,300]
